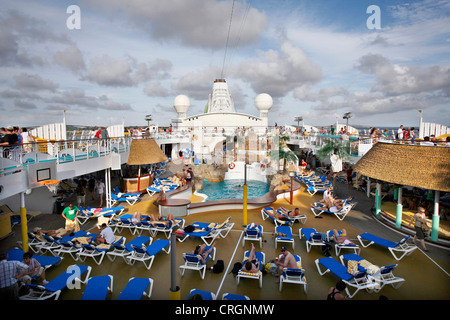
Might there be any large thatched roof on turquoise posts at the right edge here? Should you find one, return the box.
[353,142,450,192]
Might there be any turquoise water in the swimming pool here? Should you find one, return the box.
[200,179,270,201]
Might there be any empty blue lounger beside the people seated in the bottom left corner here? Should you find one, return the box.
[20,264,92,300]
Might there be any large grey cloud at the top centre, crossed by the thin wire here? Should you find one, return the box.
[85,0,268,49]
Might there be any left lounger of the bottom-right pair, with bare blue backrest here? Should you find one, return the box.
[315,257,377,298]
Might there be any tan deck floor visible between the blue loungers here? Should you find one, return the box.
[0,162,450,301]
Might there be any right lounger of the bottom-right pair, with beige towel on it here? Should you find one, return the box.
[340,253,405,292]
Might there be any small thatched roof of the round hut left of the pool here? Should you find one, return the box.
[127,139,167,166]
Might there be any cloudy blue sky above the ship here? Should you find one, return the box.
[0,0,450,126]
